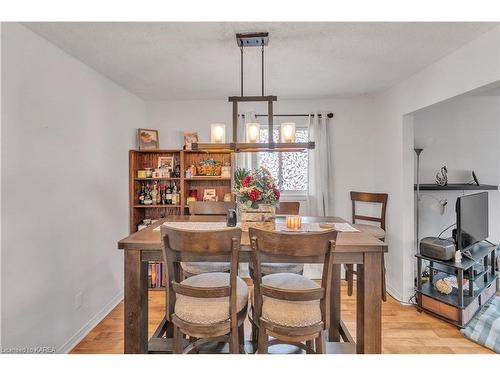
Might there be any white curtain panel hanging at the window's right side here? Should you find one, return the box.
[307,112,332,216]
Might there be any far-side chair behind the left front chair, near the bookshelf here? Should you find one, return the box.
[181,201,236,277]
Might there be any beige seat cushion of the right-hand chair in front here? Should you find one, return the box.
[254,273,321,327]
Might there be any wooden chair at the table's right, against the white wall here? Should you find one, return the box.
[344,191,389,301]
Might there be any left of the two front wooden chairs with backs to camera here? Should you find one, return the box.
[161,226,248,353]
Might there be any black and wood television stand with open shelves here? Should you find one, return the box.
[415,241,497,327]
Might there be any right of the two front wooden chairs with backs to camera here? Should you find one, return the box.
[249,228,337,354]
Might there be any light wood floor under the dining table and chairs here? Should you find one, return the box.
[72,285,493,354]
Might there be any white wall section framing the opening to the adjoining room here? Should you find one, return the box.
[370,27,500,301]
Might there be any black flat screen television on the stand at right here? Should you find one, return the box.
[456,192,488,250]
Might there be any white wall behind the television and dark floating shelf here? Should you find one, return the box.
[414,96,500,242]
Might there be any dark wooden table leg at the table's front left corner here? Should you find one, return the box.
[124,250,148,354]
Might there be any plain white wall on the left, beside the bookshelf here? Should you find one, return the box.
[1,23,144,352]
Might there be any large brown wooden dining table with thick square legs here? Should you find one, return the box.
[118,215,387,354]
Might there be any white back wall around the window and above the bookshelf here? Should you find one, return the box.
[146,97,373,220]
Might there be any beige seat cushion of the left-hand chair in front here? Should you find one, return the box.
[174,272,248,324]
